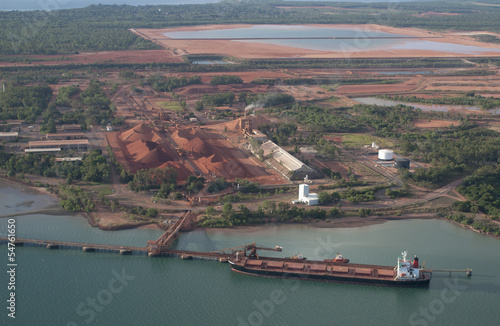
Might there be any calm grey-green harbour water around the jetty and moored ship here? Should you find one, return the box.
[0,180,500,326]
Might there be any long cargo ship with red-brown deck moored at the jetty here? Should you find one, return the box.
[229,247,432,287]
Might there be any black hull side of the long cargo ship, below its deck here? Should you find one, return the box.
[229,261,430,287]
